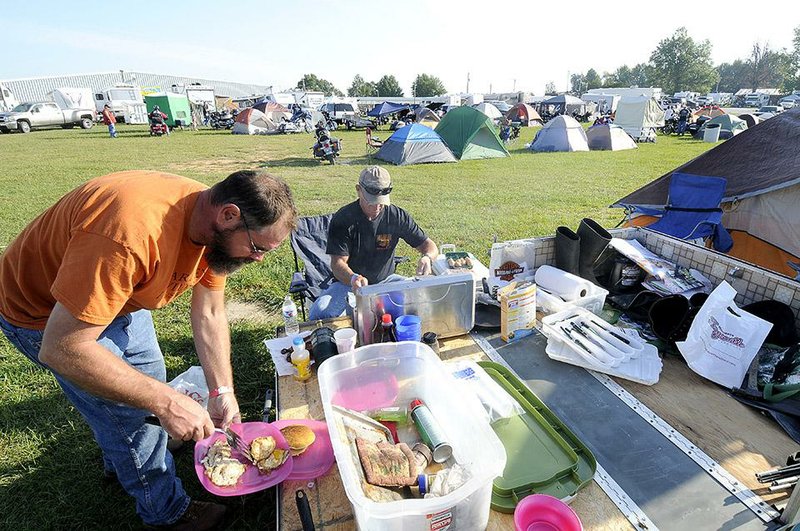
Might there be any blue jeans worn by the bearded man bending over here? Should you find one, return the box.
[0,310,191,525]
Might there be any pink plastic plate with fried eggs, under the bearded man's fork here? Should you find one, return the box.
[194,422,294,496]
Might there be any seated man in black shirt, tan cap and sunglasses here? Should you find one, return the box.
[309,166,439,321]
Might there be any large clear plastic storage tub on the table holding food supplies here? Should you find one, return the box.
[318,341,506,531]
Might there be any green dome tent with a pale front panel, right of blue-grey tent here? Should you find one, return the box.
[436,106,508,160]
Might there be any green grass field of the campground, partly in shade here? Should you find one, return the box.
[0,125,711,530]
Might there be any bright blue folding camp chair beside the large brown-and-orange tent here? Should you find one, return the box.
[647,172,733,253]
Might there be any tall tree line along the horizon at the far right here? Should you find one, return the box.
[570,26,800,94]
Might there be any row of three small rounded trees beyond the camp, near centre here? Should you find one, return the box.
[297,74,447,97]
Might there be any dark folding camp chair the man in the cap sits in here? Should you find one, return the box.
[289,214,408,321]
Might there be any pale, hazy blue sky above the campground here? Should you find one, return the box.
[0,0,800,94]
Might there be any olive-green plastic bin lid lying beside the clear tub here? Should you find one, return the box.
[478,362,597,513]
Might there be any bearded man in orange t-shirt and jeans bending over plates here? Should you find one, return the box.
[0,171,297,531]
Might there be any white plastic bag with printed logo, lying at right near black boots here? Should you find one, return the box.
[676,280,772,388]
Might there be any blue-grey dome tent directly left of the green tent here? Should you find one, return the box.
[375,124,456,166]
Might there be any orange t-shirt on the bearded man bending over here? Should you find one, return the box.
[0,171,225,329]
